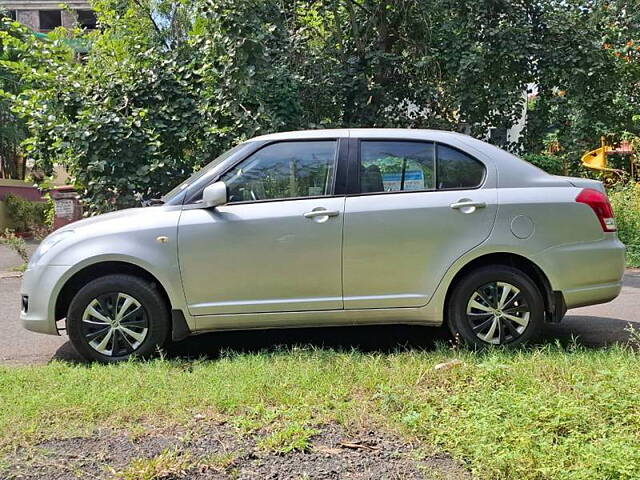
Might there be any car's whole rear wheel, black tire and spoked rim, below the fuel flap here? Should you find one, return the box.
[447,265,544,348]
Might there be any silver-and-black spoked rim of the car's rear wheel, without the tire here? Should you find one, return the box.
[467,282,531,345]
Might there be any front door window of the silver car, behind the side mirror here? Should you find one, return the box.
[220,140,337,202]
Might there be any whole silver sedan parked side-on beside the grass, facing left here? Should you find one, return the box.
[21,129,624,362]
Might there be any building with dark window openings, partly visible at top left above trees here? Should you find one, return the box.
[0,0,96,33]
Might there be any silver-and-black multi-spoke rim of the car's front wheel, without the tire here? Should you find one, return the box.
[82,292,149,357]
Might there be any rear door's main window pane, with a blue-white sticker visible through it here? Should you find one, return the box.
[360,141,435,193]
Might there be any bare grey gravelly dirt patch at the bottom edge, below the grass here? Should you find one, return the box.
[0,421,471,480]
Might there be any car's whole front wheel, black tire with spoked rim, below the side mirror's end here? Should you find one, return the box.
[67,275,170,363]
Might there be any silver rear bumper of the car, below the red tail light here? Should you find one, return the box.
[533,234,625,308]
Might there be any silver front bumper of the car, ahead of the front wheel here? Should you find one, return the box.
[20,266,69,335]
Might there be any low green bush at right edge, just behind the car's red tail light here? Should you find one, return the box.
[609,183,640,267]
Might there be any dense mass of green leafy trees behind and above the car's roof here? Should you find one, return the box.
[6,0,640,212]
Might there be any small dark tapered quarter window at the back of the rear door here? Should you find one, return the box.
[436,144,484,190]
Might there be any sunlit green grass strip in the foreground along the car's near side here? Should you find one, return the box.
[0,346,640,479]
